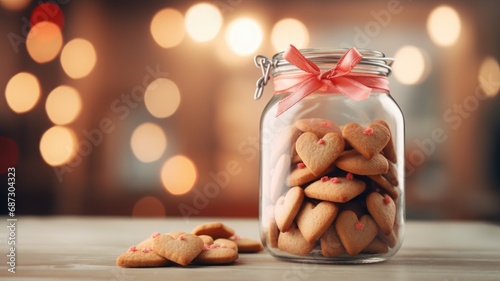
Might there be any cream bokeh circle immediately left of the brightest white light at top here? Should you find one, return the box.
[184,3,222,42]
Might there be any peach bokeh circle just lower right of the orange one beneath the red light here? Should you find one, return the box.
[61,38,97,79]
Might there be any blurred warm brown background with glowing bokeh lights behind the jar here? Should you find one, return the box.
[0,0,500,220]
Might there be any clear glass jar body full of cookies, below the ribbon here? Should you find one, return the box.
[260,92,405,263]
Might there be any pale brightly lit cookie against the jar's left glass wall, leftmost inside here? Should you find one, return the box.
[274,186,304,232]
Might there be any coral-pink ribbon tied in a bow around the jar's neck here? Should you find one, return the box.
[273,45,389,116]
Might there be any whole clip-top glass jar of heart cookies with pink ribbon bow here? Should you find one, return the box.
[255,46,405,263]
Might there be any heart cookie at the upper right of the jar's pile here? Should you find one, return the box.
[342,123,391,159]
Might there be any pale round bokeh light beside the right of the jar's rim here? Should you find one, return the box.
[392,46,429,85]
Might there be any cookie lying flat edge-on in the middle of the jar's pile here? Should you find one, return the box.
[304,176,366,203]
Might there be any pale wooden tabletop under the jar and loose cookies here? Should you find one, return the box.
[0,217,500,281]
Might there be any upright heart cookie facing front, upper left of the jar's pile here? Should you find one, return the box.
[295,132,344,176]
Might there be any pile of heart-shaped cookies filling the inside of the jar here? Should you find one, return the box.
[262,118,402,257]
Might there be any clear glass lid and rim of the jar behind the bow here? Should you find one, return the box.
[271,48,394,76]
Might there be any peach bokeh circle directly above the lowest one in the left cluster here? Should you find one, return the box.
[45,85,82,125]
